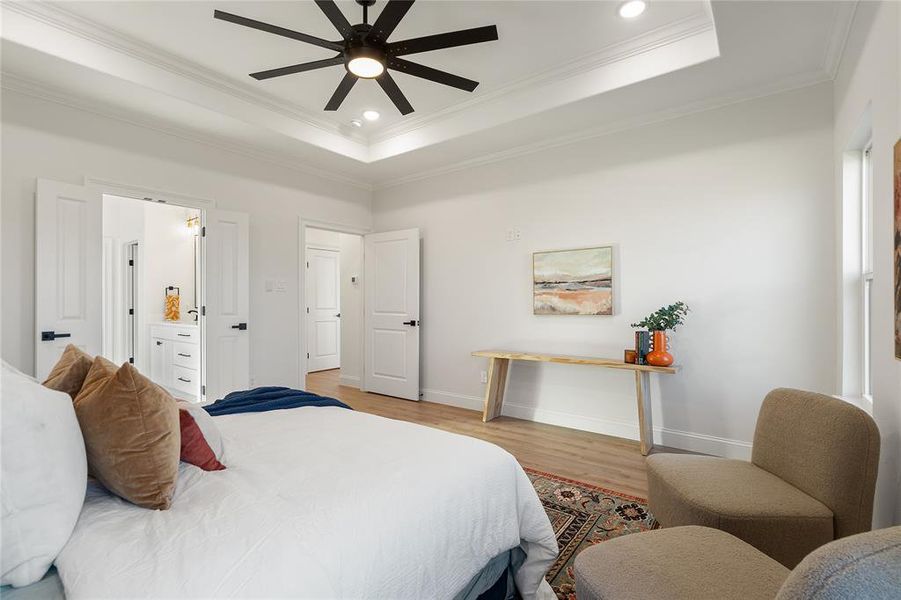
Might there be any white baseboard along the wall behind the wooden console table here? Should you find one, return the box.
[422,389,751,460]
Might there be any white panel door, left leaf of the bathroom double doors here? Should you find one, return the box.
[34,179,103,380]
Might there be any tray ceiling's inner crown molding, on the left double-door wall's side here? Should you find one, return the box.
[3,2,366,145]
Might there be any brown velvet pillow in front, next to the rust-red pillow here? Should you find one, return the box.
[75,358,181,510]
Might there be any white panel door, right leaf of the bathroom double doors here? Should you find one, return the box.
[201,209,250,402]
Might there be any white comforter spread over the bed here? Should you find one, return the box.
[56,407,557,600]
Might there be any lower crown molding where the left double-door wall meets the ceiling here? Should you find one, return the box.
[0,71,372,191]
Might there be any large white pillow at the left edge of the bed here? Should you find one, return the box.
[0,362,88,587]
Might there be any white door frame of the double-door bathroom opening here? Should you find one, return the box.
[84,175,217,403]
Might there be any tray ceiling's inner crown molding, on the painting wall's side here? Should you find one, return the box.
[369,10,715,146]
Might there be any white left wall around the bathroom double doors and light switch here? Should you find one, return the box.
[0,90,370,386]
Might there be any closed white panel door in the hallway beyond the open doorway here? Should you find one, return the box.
[306,248,341,372]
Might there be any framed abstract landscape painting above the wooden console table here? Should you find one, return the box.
[532,246,613,315]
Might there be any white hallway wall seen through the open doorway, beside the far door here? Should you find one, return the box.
[305,227,363,387]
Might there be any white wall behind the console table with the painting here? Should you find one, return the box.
[374,84,836,456]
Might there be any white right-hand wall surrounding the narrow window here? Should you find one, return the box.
[833,2,901,526]
